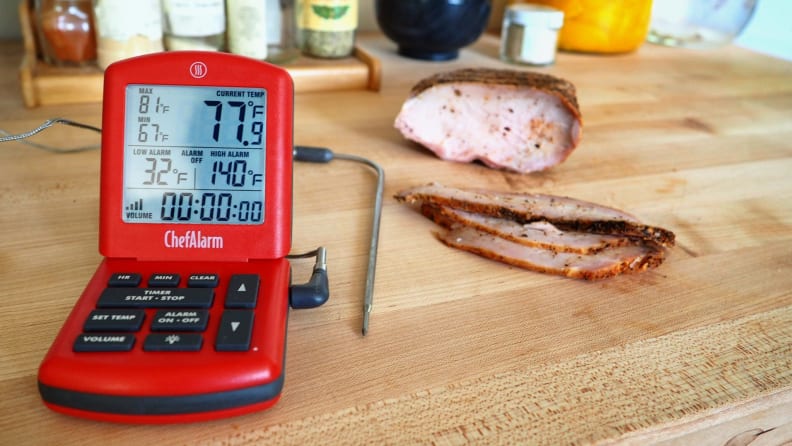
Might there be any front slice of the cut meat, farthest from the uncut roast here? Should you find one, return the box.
[436,226,665,280]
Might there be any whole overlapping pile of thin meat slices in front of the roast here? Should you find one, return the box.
[396,183,675,280]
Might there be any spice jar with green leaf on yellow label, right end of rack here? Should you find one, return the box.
[298,0,358,58]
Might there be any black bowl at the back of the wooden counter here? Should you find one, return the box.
[374,0,492,61]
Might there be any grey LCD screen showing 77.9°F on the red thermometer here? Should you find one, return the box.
[122,84,267,225]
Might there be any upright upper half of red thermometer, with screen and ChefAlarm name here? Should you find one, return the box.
[99,51,294,261]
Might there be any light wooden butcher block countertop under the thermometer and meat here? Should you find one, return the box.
[0,35,792,445]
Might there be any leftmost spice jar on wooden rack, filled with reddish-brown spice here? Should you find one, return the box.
[35,0,96,65]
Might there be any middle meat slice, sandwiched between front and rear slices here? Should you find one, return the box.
[421,204,640,254]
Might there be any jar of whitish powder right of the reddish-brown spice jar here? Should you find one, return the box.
[93,0,164,69]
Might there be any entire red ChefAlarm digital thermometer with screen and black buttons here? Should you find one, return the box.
[38,52,294,423]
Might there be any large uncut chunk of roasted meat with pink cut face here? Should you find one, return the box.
[395,68,582,173]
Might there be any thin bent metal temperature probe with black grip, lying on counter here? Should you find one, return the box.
[294,146,385,336]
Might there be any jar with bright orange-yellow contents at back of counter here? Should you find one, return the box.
[516,0,652,53]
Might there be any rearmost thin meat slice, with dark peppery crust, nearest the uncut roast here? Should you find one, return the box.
[396,183,674,247]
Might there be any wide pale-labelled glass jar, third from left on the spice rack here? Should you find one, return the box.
[162,0,226,51]
